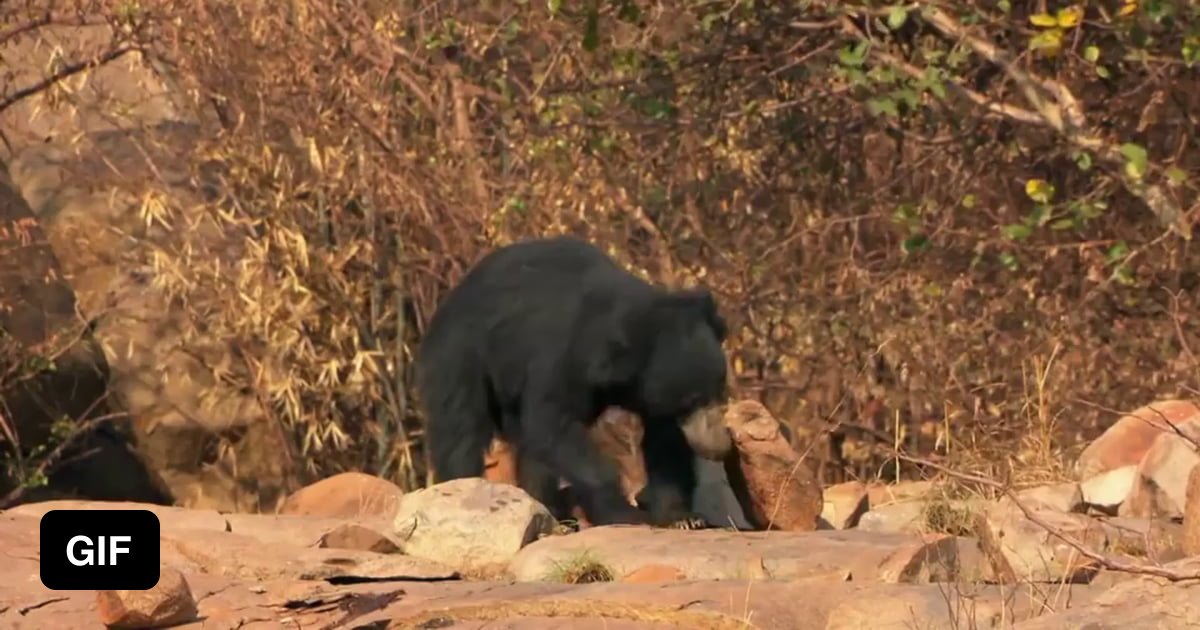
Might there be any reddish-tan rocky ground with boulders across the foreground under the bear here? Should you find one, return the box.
[0,401,1200,630]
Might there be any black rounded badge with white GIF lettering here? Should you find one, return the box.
[38,510,160,590]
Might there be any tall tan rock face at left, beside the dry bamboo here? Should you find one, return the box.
[0,20,294,511]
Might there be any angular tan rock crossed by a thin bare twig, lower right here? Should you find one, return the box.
[978,503,1108,583]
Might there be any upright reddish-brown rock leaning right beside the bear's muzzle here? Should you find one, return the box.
[725,401,824,532]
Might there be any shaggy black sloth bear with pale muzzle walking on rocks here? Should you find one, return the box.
[416,236,732,528]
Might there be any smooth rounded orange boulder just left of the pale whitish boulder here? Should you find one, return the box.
[278,473,404,520]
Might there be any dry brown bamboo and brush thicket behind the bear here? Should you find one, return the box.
[0,0,1200,496]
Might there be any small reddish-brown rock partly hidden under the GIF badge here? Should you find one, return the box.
[96,569,197,630]
